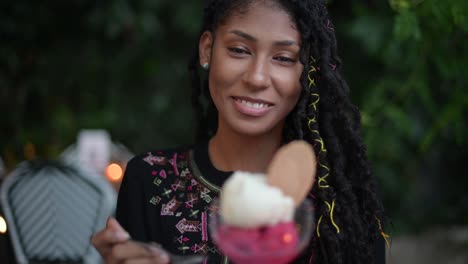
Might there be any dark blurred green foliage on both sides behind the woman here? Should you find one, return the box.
[0,0,468,233]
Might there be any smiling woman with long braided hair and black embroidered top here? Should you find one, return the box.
[93,0,386,263]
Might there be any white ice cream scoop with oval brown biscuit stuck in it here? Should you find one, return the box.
[220,141,317,227]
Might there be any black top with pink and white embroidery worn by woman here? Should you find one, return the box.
[116,143,231,263]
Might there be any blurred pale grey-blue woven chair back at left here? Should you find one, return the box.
[0,161,116,264]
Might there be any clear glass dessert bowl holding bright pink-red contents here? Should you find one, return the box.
[209,199,314,264]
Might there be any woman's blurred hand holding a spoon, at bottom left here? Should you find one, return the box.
[91,218,170,264]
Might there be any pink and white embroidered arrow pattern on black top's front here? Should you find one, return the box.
[142,151,220,255]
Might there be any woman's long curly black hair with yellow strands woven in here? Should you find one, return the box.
[189,0,385,264]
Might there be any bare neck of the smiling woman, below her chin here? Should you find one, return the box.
[208,126,281,173]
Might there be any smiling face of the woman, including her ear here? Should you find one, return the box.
[200,3,303,136]
